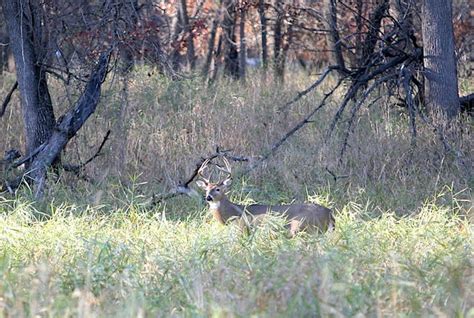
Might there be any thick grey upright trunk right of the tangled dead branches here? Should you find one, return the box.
[422,0,460,118]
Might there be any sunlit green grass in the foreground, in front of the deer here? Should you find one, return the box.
[0,188,474,317]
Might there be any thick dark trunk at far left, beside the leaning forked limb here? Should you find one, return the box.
[2,0,55,161]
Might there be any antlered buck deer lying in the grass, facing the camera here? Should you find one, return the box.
[196,157,335,237]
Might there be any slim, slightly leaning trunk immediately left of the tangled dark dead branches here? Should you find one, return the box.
[325,0,346,73]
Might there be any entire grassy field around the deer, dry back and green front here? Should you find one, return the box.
[0,70,474,317]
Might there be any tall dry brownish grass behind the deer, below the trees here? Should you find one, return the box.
[0,69,474,214]
